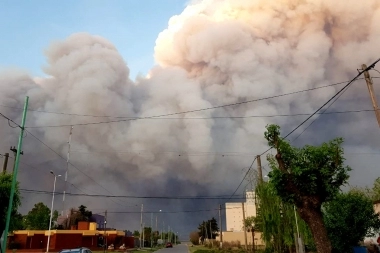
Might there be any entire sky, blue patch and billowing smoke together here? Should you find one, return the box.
[0,0,380,240]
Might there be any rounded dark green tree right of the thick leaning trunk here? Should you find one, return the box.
[323,190,380,253]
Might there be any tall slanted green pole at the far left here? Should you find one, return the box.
[2,97,29,253]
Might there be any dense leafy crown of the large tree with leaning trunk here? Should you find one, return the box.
[265,125,351,204]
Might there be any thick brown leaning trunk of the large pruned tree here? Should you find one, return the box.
[297,205,332,253]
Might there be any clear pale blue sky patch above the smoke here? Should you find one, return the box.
[0,0,188,79]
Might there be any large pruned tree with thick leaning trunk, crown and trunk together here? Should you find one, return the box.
[265,125,351,253]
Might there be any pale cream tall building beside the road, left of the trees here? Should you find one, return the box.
[226,191,256,232]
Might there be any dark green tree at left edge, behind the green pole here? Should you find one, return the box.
[0,173,21,233]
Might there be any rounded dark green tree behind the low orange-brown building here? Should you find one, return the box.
[25,202,54,230]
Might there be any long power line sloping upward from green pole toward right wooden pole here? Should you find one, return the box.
[25,82,354,128]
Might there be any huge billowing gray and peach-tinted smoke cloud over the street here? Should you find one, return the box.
[0,0,380,235]
